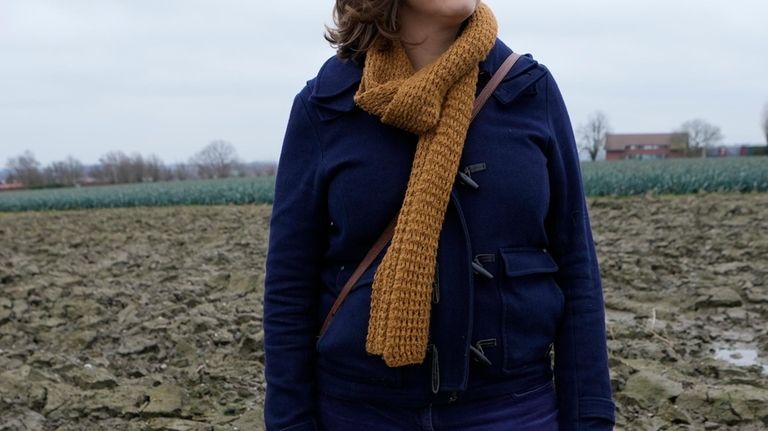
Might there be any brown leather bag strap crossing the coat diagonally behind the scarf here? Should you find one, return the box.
[319,52,520,337]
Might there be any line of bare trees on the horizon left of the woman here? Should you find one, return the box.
[5,140,277,188]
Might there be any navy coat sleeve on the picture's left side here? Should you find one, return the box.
[263,89,330,431]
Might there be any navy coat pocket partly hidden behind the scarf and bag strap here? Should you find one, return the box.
[316,265,402,386]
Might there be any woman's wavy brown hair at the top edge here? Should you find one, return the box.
[325,0,401,60]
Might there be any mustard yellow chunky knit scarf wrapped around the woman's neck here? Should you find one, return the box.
[355,3,497,367]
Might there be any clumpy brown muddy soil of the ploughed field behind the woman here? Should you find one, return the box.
[0,193,768,431]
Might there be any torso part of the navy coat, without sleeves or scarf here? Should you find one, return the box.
[296,41,563,405]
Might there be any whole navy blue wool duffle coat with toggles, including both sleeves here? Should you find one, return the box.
[264,40,614,431]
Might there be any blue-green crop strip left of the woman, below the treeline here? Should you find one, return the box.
[0,176,275,211]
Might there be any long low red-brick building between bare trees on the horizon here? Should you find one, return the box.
[605,133,688,160]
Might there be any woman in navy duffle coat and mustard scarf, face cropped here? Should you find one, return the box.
[264,0,614,431]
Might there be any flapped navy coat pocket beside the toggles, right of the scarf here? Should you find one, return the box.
[498,247,565,374]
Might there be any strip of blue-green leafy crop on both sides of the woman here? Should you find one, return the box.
[0,157,768,211]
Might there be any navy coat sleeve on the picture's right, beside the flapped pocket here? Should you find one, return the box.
[546,69,615,431]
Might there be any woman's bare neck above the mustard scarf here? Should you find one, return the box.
[398,5,462,70]
